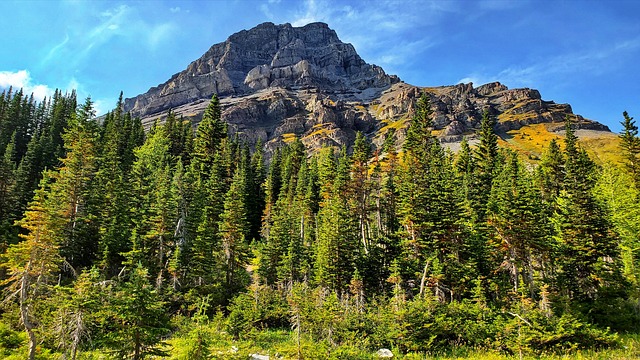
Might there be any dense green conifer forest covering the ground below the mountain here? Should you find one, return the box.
[0,89,640,360]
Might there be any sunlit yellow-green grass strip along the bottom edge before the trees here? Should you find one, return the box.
[0,326,640,360]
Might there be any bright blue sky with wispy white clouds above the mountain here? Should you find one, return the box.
[0,0,640,131]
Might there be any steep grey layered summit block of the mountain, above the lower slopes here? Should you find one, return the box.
[125,23,399,117]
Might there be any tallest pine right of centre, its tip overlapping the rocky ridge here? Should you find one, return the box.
[398,92,464,300]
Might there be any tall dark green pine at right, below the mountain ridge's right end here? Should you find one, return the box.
[554,117,621,301]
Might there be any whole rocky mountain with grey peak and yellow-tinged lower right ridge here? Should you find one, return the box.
[125,23,610,159]
